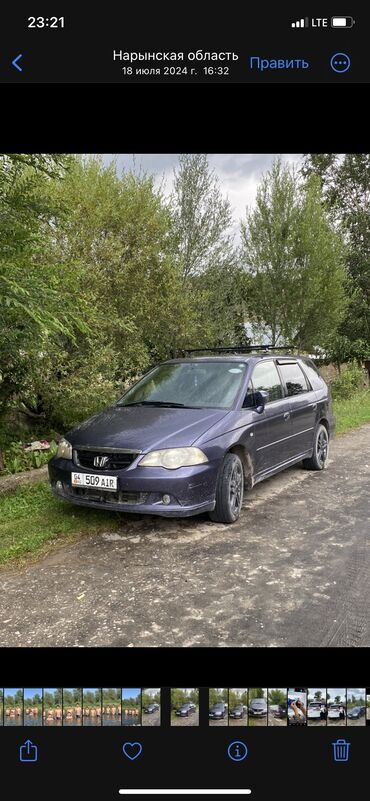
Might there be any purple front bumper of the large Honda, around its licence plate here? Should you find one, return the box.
[48,456,219,517]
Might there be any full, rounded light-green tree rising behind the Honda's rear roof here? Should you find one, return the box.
[241,160,346,350]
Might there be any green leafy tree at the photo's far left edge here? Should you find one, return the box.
[0,154,88,460]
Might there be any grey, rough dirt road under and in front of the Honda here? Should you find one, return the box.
[0,425,370,647]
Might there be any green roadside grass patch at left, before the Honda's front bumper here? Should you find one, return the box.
[0,481,119,565]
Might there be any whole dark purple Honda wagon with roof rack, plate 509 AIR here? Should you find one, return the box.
[48,346,335,523]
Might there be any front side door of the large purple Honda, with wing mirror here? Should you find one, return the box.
[244,359,291,476]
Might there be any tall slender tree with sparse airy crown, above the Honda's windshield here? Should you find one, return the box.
[170,153,245,346]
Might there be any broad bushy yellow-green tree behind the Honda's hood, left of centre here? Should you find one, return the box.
[28,158,189,428]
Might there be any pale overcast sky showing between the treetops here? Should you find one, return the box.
[104,153,302,227]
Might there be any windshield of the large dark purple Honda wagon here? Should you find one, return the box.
[117,361,246,409]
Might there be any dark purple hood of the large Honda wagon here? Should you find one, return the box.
[66,406,230,451]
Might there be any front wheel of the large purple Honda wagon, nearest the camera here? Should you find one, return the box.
[209,453,244,523]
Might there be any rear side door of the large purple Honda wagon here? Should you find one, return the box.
[277,359,317,458]
